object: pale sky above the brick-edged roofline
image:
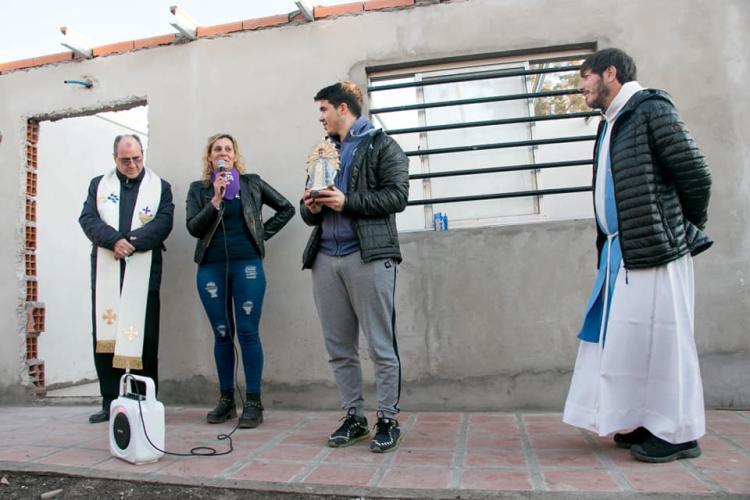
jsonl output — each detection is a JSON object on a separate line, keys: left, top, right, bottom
{"left": 0, "top": 0, "right": 352, "bottom": 62}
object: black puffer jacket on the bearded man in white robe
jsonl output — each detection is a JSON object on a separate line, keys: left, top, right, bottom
{"left": 594, "top": 89, "right": 713, "bottom": 269}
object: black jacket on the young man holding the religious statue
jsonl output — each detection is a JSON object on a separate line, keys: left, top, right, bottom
{"left": 300, "top": 130, "right": 409, "bottom": 269}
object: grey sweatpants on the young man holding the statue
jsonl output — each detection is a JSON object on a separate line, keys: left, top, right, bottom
{"left": 312, "top": 252, "right": 401, "bottom": 418}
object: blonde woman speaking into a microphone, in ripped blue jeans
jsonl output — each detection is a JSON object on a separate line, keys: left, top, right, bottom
{"left": 187, "top": 134, "right": 294, "bottom": 428}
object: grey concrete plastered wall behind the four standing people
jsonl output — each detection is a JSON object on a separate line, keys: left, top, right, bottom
{"left": 0, "top": 0, "right": 750, "bottom": 410}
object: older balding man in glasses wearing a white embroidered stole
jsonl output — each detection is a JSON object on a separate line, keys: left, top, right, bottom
{"left": 78, "top": 135, "right": 174, "bottom": 423}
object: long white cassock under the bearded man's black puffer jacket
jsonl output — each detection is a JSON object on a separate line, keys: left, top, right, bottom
{"left": 563, "top": 82, "right": 705, "bottom": 444}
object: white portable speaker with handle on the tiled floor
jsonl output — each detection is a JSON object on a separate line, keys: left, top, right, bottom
{"left": 109, "top": 374, "right": 164, "bottom": 464}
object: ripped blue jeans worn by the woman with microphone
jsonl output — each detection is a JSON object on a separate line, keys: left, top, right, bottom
{"left": 197, "top": 259, "right": 266, "bottom": 394}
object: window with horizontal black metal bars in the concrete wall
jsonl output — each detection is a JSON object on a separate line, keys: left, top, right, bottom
{"left": 368, "top": 50, "right": 599, "bottom": 231}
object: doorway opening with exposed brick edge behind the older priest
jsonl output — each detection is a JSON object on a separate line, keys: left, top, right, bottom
{"left": 25, "top": 102, "right": 148, "bottom": 399}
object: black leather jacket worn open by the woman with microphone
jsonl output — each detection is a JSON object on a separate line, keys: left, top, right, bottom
{"left": 186, "top": 174, "right": 294, "bottom": 264}
